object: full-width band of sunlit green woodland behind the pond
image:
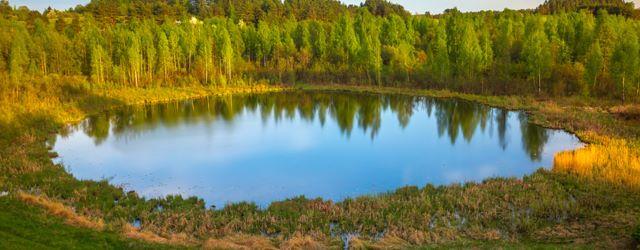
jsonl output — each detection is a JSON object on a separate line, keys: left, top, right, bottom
{"left": 0, "top": 0, "right": 640, "bottom": 101}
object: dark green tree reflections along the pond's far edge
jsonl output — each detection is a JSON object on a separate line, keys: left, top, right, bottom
{"left": 70, "top": 91, "right": 549, "bottom": 161}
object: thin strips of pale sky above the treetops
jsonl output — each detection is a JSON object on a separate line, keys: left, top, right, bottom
{"left": 9, "top": 0, "right": 640, "bottom": 14}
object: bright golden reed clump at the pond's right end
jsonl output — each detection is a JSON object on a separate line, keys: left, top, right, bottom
{"left": 553, "top": 139, "right": 640, "bottom": 188}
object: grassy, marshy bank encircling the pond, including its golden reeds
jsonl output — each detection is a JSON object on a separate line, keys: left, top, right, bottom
{"left": 0, "top": 79, "right": 640, "bottom": 248}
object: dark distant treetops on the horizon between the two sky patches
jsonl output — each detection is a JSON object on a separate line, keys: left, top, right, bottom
{"left": 74, "top": 0, "right": 409, "bottom": 23}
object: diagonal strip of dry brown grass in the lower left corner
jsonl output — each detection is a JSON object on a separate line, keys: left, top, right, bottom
{"left": 18, "top": 192, "right": 104, "bottom": 230}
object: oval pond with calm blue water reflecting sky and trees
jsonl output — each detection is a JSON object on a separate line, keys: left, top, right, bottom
{"left": 54, "top": 91, "right": 582, "bottom": 208}
